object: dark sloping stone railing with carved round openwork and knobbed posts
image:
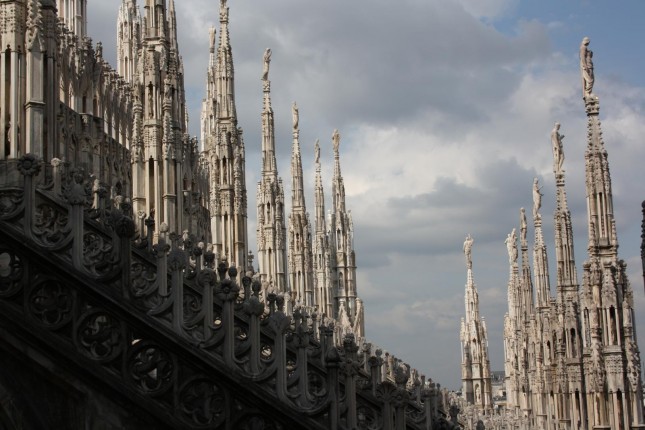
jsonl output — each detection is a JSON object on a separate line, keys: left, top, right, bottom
{"left": 0, "top": 155, "right": 457, "bottom": 430}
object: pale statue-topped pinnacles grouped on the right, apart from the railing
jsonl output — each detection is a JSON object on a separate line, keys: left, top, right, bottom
{"left": 461, "top": 37, "right": 645, "bottom": 430}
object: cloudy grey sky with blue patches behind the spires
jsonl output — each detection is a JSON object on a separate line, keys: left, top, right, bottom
{"left": 88, "top": 0, "right": 645, "bottom": 388}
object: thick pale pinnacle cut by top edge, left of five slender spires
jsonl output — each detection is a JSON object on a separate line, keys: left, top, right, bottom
{"left": 117, "top": 0, "right": 196, "bottom": 239}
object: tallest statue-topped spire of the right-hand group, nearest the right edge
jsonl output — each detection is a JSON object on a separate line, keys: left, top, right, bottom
{"left": 580, "top": 37, "right": 645, "bottom": 428}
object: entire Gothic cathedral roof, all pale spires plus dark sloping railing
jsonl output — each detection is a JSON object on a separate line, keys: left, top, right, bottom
{"left": 0, "top": 0, "right": 645, "bottom": 430}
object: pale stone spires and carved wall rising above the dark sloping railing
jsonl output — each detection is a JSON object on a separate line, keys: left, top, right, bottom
{"left": 0, "top": 0, "right": 363, "bottom": 341}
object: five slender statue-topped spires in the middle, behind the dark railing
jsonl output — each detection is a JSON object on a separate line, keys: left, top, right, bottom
{"left": 186, "top": 0, "right": 364, "bottom": 339}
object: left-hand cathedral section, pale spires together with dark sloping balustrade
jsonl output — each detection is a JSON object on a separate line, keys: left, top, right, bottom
{"left": 0, "top": 0, "right": 456, "bottom": 429}
